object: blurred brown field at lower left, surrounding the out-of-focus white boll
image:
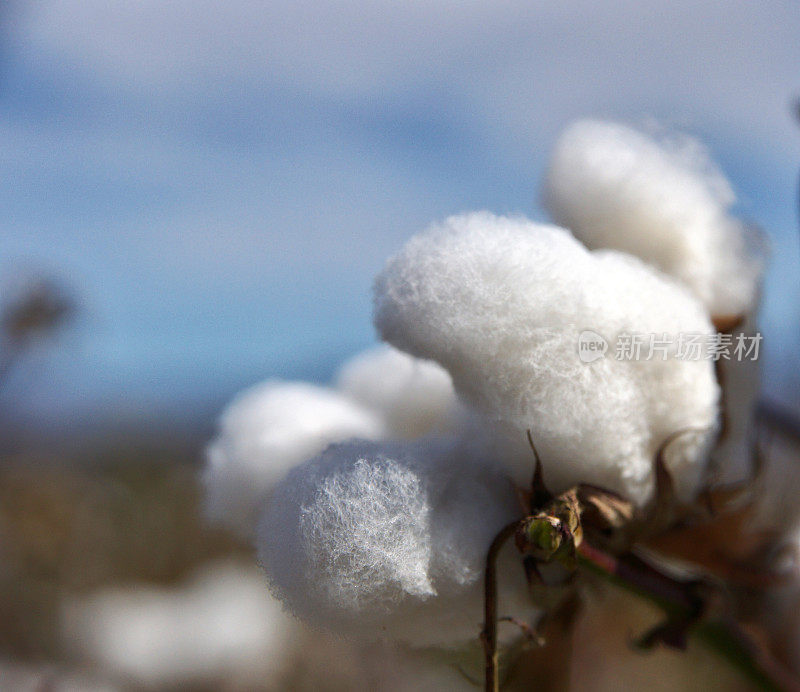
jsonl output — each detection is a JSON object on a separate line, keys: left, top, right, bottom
{"left": 0, "top": 431, "right": 450, "bottom": 692}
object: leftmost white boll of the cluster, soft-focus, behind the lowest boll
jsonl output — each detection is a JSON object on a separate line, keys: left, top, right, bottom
{"left": 203, "top": 381, "right": 385, "bottom": 538}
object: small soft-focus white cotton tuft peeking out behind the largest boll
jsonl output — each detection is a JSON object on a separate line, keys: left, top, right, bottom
{"left": 337, "top": 345, "right": 464, "bottom": 439}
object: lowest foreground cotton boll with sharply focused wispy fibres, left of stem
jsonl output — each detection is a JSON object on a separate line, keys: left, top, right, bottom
{"left": 257, "top": 440, "right": 530, "bottom": 646}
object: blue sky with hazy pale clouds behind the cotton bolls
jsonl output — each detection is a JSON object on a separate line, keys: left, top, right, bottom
{"left": 0, "top": 0, "right": 800, "bottom": 428}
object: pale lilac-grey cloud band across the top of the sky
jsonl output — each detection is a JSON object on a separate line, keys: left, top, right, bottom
{"left": 17, "top": 0, "right": 800, "bottom": 162}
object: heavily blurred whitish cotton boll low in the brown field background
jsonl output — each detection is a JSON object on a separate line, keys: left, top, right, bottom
{"left": 62, "top": 564, "right": 296, "bottom": 689}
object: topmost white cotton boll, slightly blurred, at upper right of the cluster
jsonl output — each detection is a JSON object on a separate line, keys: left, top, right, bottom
{"left": 543, "top": 120, "right": 763, "bottom": 316}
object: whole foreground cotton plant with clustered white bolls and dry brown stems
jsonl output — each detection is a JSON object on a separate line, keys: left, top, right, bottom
{"left": 200, "top": 122, "right": 792, "bottom": 690}
